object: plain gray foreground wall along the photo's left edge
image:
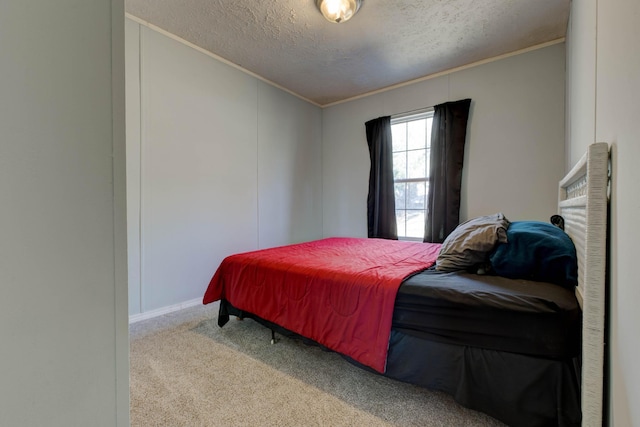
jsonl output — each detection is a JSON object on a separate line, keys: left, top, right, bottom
{"left": 0, "top": 0, "right": 129, "bottom": 427}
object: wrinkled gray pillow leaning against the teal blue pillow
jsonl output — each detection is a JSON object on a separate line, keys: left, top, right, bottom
{"left": 436, "top": 213, "right": 509, "bottom": 271}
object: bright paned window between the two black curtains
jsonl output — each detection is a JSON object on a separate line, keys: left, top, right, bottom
{"left": 391, "top": 111, "right": 433, "bottom": 241}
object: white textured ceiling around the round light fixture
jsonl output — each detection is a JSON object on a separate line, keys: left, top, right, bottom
{"left": 125, "top": 0, "right": 570, "bottom": 106}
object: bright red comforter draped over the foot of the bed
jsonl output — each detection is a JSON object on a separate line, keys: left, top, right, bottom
{"left": 203, "top": 238, "right": 440, "bottom": 372}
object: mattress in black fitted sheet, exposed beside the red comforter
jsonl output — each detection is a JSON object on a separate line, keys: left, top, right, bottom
{"left": 392, "top": 269, "right": 581, "bottom": 359}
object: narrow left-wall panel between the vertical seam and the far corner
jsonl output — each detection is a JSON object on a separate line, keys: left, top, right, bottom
{"left": 258, "top": 82, "right": 322, "bottom": 248}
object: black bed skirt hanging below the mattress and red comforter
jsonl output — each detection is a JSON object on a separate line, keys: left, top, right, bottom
{"left": 218, "top": 300, "right": 582, "bottom": 427}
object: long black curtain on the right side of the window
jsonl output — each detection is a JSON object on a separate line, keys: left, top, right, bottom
{"left": 424, "top": 99, "right": 471, "bottom": 243}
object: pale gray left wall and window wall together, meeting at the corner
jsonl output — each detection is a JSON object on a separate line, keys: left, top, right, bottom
{"left": 126, "top": 25, "right": 565, "bottom": 315}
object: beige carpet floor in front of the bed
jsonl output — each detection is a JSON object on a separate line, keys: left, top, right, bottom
{"left": 130, "top": 304, "right": 503, "bottom": 427}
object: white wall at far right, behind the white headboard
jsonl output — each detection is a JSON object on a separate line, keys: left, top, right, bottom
{"left": 567, "top": 0, "right": 640, "bottom": 427}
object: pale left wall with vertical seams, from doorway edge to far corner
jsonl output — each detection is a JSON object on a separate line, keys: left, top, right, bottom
{"left": 127, "top": 20, "right": 322, "bottom": 314}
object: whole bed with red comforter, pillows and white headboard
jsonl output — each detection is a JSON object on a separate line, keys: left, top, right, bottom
{"left": 203, "top": 143, "right": 608, "bottom": 427}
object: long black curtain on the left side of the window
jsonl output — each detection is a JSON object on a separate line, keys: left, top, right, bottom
{"left": 365, "top": 116, "right": 398, "bottom": 240}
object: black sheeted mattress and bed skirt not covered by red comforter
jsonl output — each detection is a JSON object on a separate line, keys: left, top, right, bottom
{"left": 385, "top": 270, "right": 582, "bottom": 427}
